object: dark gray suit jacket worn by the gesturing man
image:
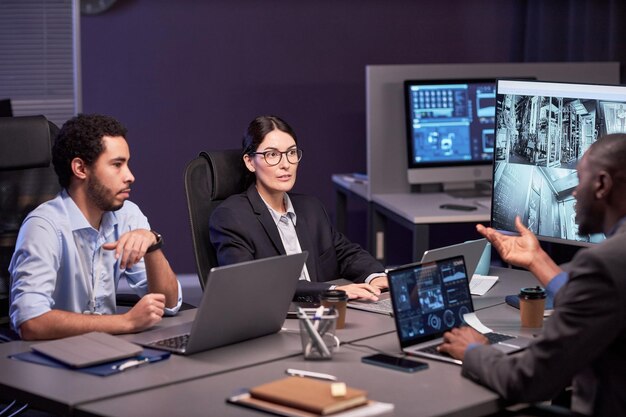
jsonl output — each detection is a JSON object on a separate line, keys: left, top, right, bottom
{"left": 462, "top": 219, "right": 626, "bottom": 416}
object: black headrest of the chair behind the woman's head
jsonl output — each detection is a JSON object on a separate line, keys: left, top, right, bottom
{"left": 200, "top": 149, "right": 250, "bottom": 200}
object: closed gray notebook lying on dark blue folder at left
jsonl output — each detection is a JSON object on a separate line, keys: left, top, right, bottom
{"left": 31, "top": 332, "right": 143, "bottom": 368}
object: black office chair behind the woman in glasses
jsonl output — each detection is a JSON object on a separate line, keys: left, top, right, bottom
{"left": 185, "top": 150, "right": 254, "bottom": 290}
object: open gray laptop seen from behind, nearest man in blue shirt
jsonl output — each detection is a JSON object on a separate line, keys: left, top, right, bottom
{"left": 133, "top": 251, "right": 308, "bottom": 355}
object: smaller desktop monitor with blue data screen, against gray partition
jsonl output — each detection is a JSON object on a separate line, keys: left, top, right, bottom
{"left": 404, "top": 79, "right": 496, "bottom": 190}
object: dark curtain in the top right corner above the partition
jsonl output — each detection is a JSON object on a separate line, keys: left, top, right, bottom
{"left": 523, "top": 0, "right": 626, "bottom": 82}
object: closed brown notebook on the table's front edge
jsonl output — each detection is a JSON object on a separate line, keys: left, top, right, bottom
{"left": 250, "top": 376, "right": 367, "bottom": 415}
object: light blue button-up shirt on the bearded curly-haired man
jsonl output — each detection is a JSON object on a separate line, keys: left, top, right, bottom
{"left": 9, "top": 190, "right": 182, "bottom": 331}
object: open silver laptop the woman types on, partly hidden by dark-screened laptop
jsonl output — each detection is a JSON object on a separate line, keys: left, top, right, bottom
{"left": 348, "top": 239, "right": 487, "bottom": 316}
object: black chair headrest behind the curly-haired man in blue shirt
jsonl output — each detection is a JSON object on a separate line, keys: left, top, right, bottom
{"left": 0, "top": 116, "right": 54, "bottom": 170}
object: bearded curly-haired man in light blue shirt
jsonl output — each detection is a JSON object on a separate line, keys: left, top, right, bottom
{"left": 9, "top": 115, "right": 182, "bottom": 339}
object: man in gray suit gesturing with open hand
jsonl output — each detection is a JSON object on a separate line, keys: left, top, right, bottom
{"left": 439, "top": 134, "right": 626, "bottom": 416}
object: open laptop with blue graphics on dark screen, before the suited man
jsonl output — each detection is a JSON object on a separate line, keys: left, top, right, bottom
{"left": 388, "top": 256, "right": 531, "bottom": 364}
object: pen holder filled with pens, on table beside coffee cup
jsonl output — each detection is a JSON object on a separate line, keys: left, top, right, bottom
{"left": 298, "top": 308, "right": 339, "bottom": 360}
